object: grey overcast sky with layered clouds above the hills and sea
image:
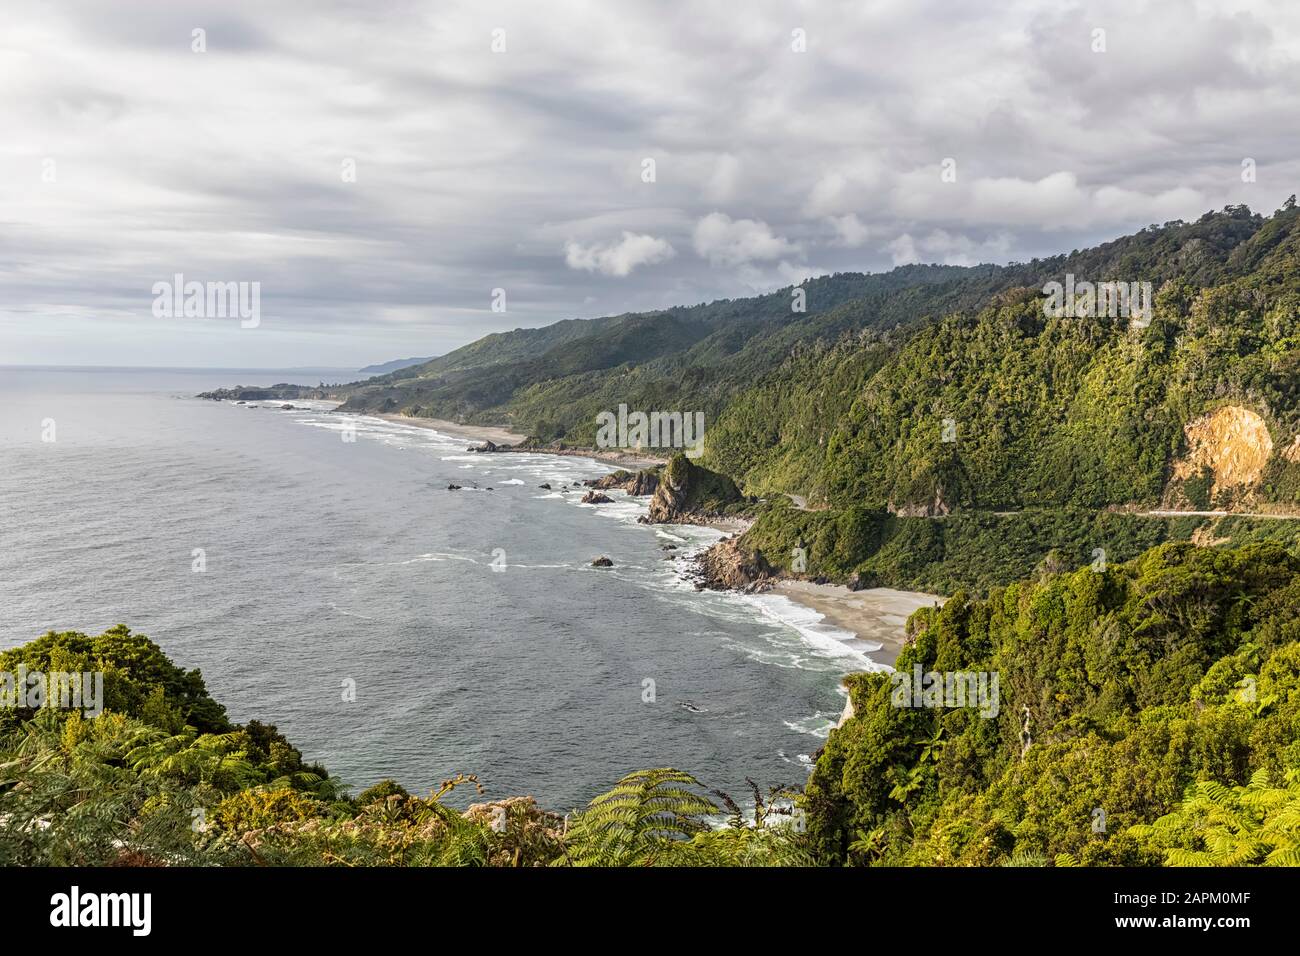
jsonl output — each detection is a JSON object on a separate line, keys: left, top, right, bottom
{"left": 0, "top": 0, "right": 1300, "bottom": 368}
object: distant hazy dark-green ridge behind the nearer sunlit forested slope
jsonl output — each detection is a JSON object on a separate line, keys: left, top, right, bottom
{"left": 335, "top": 267, "right": 971, "bottom": 429}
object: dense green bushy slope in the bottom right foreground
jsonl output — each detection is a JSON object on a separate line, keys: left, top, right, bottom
{"left": 806, "top": 545, "right": 1300, "bottom": 866}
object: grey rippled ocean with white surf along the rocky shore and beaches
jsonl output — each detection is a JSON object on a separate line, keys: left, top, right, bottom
{"left": 0, "top": 367, "right": 876, "bottom": 810}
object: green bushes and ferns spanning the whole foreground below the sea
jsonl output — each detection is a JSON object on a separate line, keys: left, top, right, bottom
{"left": 0, "top": 542, "right": 1300, "bottom": 866}
